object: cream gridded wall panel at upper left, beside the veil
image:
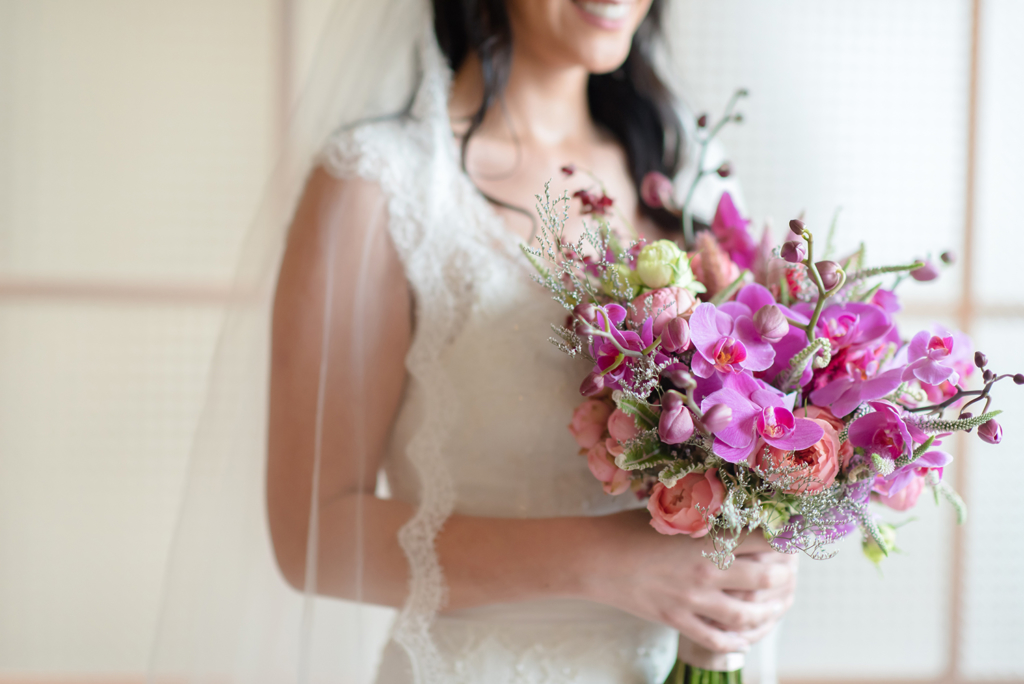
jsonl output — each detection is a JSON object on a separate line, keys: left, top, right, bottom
{"left": 0, "top": 0, "right": 276, "bottom": 281}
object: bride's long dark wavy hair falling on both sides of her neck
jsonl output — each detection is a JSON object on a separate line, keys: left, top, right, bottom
{"left": 433, "top": 0, "right": 684, "bottom": 229}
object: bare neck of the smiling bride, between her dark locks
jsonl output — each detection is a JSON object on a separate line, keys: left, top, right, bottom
{"left": 449, "top": 53, "right": 598, "bottom": 146}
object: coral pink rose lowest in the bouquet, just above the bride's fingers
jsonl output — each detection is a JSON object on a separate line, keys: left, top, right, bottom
{"left": 647, "top": 468, "right": 725, "bottom": 539}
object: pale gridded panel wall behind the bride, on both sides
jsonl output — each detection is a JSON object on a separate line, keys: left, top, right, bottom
{"left": 0, "top": 0, "right": 1024, "bottom": 680}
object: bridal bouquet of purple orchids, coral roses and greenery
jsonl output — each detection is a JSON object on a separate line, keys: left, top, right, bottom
{"left": 524, "top": 93, "right": 1024, "bottom": 681}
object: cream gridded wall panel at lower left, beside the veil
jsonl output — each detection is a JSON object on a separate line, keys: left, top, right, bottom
{"left": 0, "top": 301, "right": 220, "bottom": 674}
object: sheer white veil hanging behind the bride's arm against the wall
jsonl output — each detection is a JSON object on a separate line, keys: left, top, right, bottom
{"left": 148, "top": 0, "right": 431, "bottom": 683}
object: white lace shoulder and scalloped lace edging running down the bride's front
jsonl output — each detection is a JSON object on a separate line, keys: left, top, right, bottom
{"left": 321, "top": 28, "right": 464, "bottom": 684}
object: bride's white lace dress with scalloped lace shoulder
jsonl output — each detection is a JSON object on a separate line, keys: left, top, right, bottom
{"left": 324, "top": 40, "right": 749, "bottom": 684}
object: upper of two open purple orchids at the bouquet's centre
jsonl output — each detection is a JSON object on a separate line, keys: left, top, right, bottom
{"left": 690, "top": 294, "right": 775, "bottom": 378}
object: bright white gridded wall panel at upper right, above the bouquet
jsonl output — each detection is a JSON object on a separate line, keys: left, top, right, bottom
{"left": 672, "top": 0, "right": 971, "bottom": 309}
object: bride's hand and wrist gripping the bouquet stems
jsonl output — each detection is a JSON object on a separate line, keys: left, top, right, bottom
{"left": 586, "top": 511, "right": 797, "bottom": 653}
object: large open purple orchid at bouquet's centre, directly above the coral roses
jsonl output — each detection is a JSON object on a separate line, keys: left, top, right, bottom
{"left": 700, "top": 373, "right": 824, "bottom": 463}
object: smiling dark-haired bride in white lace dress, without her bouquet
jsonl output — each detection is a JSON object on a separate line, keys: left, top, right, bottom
{"left": 155, "top": 0, "right": 796, "bottom": 684}
